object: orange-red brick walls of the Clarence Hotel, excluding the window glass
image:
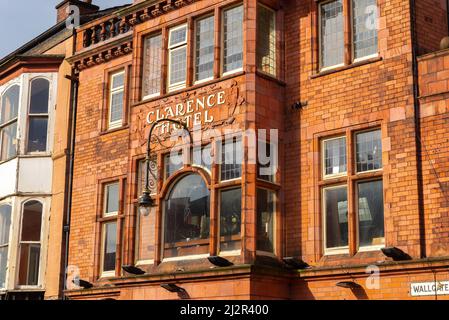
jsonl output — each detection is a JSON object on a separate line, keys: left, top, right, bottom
{"left": 66, "top": 0, "right": 449, "bottom": 299}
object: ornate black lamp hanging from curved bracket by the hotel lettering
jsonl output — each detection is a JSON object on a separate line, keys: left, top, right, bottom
{"left": 138, "top": 119, "right": 192, "bottom": 216}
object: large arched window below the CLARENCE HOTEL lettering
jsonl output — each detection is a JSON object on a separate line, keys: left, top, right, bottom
{"left": 164, "top": 174, "right": 210, "bottom": 258}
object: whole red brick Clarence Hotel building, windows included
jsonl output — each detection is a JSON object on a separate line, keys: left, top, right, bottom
{"left": 65, "top": 0, "right": 449, "bottom": 299}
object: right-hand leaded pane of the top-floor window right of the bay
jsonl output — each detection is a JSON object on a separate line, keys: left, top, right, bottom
{"left": 352, "top": 0, "right": 377, "bottom": 59}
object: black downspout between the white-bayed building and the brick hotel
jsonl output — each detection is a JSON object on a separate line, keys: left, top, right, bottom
{"left": 61, "top": 29, "right": 79, "bottom": 300}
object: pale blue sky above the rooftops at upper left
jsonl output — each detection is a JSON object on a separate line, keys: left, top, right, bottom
{"left": 0, "top": 0, "right": 132, "bottom": 58}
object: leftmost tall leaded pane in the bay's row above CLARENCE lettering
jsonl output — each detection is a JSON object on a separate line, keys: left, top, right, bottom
{"left": 142, "top": 34, "right": 162, "bottom": 97}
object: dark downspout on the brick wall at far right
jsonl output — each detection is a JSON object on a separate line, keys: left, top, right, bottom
{"left": 410, "top": 0, "right": 426, "bottom": 258}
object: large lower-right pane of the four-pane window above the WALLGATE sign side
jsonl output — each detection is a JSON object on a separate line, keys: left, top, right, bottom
{"left": 358, "top": 180, "right": 385, "bottom": 247}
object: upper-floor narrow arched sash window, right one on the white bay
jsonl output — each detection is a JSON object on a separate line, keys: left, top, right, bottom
{"left": 27, "top": 78, "right": 50, "bottom": 153}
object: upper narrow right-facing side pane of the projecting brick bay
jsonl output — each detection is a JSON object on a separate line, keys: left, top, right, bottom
{"left": 257, "top": 5, "right": 276, "bottom": 76}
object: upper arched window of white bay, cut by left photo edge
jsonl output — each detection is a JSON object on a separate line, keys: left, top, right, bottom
{"left": 0, "top": 85, "right": 20, "bottom": 161}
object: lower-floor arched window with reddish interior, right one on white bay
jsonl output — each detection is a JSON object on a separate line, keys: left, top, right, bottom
{"left": 18, "top": 200, "right": 43, "bottom": 286}
